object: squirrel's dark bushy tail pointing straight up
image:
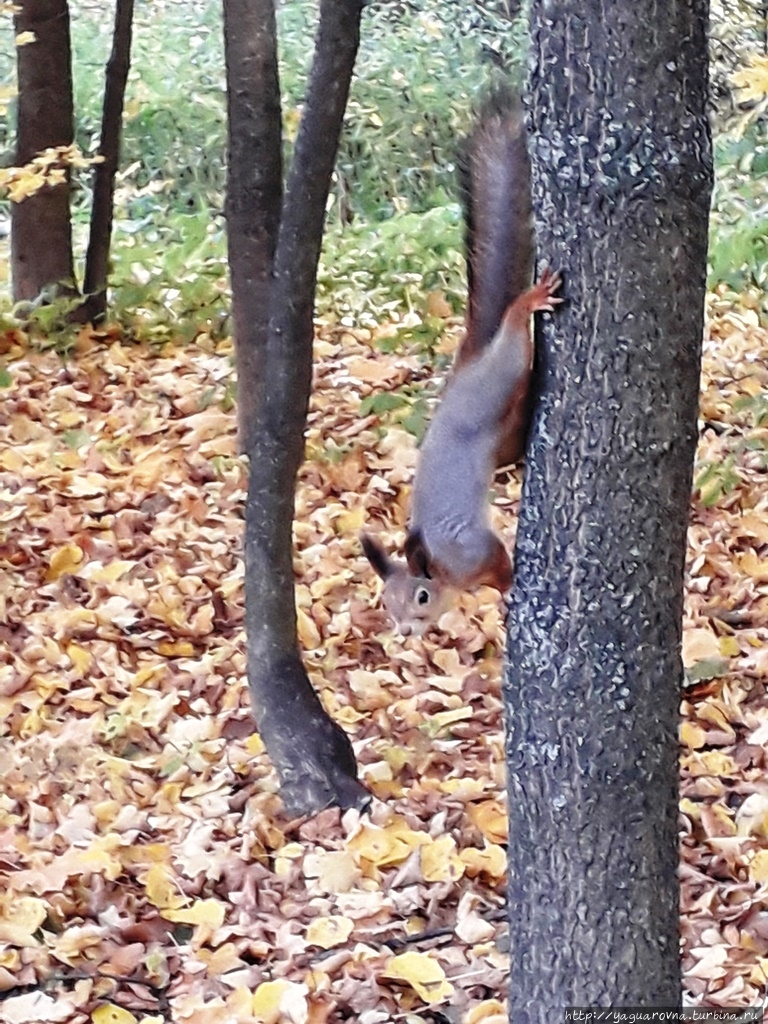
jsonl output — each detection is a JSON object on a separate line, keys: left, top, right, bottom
{"left": 458, "top": 88, "right": 534, "bottom": 365}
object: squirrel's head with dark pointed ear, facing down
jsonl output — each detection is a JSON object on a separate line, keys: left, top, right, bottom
{"left": 360, "top": 534, "right": 447, "bottom": 636}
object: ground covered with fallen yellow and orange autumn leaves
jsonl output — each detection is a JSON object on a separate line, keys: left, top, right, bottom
{"left": 0, "top": 299, "right": 768, "bottom": 1024}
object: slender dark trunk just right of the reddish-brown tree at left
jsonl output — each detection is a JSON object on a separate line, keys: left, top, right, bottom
{"left": 79, "top": 0, "right": 133, "bottom": 323}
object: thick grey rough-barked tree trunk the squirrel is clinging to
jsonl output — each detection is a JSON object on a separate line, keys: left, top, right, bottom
{"left": 505, "top": 0, "right": 712, "bottom": 1011}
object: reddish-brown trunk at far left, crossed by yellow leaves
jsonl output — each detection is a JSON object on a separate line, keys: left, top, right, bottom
{"left": 10, "top": 0, "right": 75, "bottom": 302}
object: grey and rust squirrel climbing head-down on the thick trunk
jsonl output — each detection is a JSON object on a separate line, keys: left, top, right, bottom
{"left": 360, "top": 97, "right": 562, "bottom": 636}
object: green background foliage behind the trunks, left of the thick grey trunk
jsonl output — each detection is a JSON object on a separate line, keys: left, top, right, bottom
{"left": 0, "top": 0, "right": 523, "bottom": 327}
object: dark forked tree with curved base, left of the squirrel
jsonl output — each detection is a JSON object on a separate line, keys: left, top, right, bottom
{"left": 224, "top": 0, "right": 367, "bottom": 813}
